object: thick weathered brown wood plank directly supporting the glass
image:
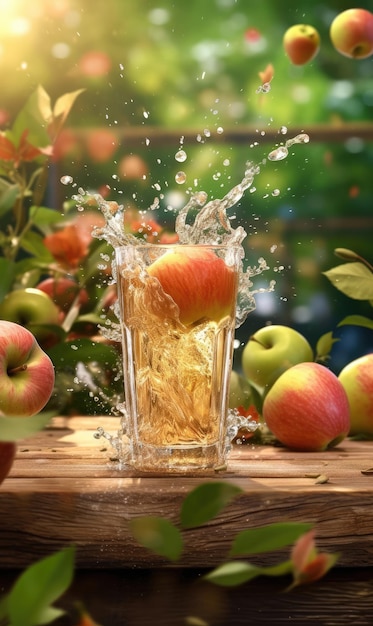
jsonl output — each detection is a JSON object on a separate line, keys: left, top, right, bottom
{"left": 0, "top": 418, "right": 373, "bottom": 568}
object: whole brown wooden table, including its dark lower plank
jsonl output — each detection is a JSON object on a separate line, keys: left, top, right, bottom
{"left": 0, "top": 416, "right": 373, "bottom": 626}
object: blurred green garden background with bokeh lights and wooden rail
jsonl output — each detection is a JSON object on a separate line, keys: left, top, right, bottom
{"left": 0, "top": 0, "right": 373, "bottom": 371}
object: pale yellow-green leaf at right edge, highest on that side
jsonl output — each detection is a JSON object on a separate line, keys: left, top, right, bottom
{"left": 323, "top": 263, "right": 373, "bottom": 300}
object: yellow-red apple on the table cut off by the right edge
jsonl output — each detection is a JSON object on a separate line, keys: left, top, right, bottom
{"left": 338, "top": 353, "right": 373, "bottom": 435}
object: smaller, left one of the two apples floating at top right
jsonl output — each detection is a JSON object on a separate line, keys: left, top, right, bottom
{"left": 283, "top": 24, "right": 320, "bottom": 65}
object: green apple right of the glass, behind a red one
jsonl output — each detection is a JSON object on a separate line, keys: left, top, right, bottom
{"left": 242, "top": 324, "right": 314, "bottom": 391}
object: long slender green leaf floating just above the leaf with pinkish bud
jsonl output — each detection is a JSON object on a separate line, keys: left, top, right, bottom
{"left": 230, "top": 522, "right": 312, "bottom": 556}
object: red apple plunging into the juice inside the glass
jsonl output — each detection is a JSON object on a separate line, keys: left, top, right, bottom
{"left": 147, "top": 246, "right": 238, "bottom": 325}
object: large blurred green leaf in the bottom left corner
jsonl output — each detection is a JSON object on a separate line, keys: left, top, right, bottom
{"left": 7, "top": 547, "right": 75, "bottom": 626}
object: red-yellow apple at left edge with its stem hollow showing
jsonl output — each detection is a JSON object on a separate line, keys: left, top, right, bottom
{"left": 0, "top": 320, "right": 54, "bottom": 417}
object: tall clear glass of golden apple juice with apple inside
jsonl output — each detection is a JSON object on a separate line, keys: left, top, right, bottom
{"left": 116, "top": 244, "right": 241, "bottom": 470}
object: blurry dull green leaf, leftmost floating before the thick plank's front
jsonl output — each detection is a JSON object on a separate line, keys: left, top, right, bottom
{"left": 130, "top": 516, "right": 183, "bottom": 561}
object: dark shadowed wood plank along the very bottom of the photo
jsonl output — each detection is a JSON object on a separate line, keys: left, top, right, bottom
{"left": 0, "top": 568, "right": 373, "bottom": 626}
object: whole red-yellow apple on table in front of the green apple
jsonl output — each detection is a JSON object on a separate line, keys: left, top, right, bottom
{"left": 263, "top": 363, "right": 350, "bottom": 451}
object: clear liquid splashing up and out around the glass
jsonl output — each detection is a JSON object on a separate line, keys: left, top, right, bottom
{"left": 73, "top": 133, "right": 309, "bottom": 464}
